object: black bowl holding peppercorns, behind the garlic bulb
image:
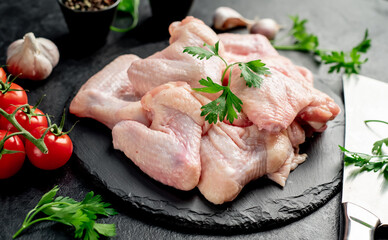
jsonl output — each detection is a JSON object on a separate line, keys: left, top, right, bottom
{"left": 57, "top": 0, "right": 120, "bottom": 48}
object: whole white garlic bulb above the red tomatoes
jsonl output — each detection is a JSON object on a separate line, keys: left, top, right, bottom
{"left": 7, "top": 32, "right": 59, "bottom": 80}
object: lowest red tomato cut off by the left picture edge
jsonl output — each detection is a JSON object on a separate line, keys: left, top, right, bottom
{"left": 0, "top": 130, "right": 26, "bottom": 179}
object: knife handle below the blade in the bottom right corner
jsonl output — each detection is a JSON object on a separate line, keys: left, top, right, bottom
{"left": 342, "top": 202, "right": 380, "bottom": 240}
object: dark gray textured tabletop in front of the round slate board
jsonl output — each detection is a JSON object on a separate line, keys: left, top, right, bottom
{"left": 0, "top": 162, "right": 340, "bottom": 240}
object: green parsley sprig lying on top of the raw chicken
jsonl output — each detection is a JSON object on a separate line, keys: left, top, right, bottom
{"left": 183, "top": 41, "right": 271, "bottom": 124}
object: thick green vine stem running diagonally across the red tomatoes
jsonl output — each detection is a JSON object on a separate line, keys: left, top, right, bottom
{"left": 0, "top": 104, "right": 48, "bottom": 154}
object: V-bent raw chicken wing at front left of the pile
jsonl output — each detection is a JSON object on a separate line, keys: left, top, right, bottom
{"left": 112, "top": 82, "right": 204, "bottom": 190}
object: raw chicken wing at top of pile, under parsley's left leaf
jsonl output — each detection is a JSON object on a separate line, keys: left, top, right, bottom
{"left": 128, "top": 17, "right": 225, "bottom": 98}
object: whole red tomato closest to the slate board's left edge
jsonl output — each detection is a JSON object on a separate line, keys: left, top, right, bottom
{"left": 26, "top": 127, "right": 73, "bottom": 170}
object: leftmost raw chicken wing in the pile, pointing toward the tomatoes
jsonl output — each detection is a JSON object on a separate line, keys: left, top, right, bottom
{"left": 70, "top": 54, "right": 149, "bottom": 128}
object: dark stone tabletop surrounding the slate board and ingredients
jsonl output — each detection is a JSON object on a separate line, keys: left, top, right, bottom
{"left": 0, "top": 0, "right": 388, "bottom": 239}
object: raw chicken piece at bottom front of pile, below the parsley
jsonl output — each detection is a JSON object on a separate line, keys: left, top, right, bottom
{"left": 198, "top": 123, "right": 306, "bottom": 204}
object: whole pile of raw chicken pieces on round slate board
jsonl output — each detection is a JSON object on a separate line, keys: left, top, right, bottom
{"left": 70, "top": 17, "right": 340, "bottom": 204}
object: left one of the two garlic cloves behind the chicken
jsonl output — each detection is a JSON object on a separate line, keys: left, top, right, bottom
{"left": 213, "top": 7, "right": 252, "bottom": 31}
